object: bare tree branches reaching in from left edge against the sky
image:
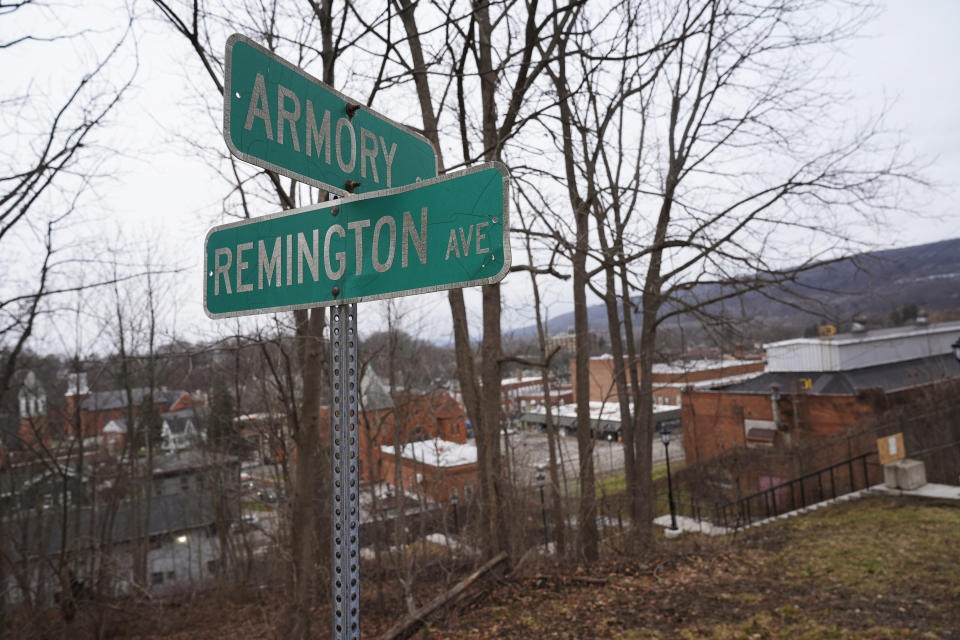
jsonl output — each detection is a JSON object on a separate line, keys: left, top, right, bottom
{"left": 0, "top": 3, "right": 132, "bottom": 424}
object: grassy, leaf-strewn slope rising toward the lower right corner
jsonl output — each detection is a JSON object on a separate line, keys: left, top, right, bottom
{"left": 420, "top": 498, "right": 960, "bottom": 640}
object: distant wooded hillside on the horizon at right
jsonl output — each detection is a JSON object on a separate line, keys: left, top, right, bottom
{"left": 513, "top": 238, "right": 960, "bottom": 338}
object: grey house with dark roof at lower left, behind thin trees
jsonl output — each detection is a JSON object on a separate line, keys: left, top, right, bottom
{"left": 0, "top": 451, "right": 240, "bottom": 606}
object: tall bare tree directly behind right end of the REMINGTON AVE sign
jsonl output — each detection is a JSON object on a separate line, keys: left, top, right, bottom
{"left": 397, "top": 0, "right": 579, "bottom": 558}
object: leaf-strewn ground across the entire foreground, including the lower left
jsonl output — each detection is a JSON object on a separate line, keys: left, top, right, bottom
{"left": 9, "top": 497, "right": 960, "bottom": 640}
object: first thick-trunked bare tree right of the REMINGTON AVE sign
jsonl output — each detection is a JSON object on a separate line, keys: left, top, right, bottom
{"left": 549, "top": 3, "right": 660, "bottom": 562}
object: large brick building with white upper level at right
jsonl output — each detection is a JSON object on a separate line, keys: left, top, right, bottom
{"left": 681, "top": 323, "right": 960, "bottom": 491}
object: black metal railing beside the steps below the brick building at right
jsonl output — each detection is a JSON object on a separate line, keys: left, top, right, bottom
{"left": 658, "top": 451, "right": 877, "bottom": 529}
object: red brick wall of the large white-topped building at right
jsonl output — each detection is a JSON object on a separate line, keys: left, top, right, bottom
{"left": 681, "top": 380, "right": 960, "bottom": 495}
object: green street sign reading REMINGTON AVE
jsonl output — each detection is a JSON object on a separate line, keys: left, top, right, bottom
{"left": 203, "top": 162, "right": 510, "bottom": 318}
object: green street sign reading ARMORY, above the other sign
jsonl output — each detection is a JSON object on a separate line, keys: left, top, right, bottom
{"left": 223, "top": 34, "right": 437, "bottom": 195}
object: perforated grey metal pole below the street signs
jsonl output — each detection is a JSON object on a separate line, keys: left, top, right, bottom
{"left": 330, "top": 304, "right": 360, "bottom": 640}
